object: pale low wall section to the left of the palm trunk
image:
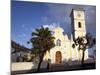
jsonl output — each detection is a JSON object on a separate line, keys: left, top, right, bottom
{"left": 11, "top": 62, "right": 37, "bottom": 71}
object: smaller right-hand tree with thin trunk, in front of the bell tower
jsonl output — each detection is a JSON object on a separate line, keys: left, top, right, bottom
{"left": 72, "top": 33, "right": 96, "bottom": 67}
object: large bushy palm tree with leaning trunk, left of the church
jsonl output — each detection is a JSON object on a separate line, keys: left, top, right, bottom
{"left": 27, "top": 27, "right": 54, "bottom": 72}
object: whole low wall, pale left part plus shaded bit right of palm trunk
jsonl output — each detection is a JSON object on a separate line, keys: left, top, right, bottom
{"left": 11, "top": 62, "right": 47, "bottom": 71}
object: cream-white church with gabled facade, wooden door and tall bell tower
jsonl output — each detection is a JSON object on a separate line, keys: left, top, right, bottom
{"left": 44, "top": 9, "right": 88, "bottom": 64}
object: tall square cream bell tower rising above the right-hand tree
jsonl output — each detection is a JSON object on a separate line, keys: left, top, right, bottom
{"left": 70, "top": 9, "right": 86, "bottom": 40}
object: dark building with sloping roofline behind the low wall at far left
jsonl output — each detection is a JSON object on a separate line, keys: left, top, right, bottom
{"left": 11, "top": 41, "right": 31, "bottom": 62}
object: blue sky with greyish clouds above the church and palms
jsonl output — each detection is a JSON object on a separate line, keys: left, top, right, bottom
{"left": 11, "top": 1, "right": 96, "bottom": 48}
